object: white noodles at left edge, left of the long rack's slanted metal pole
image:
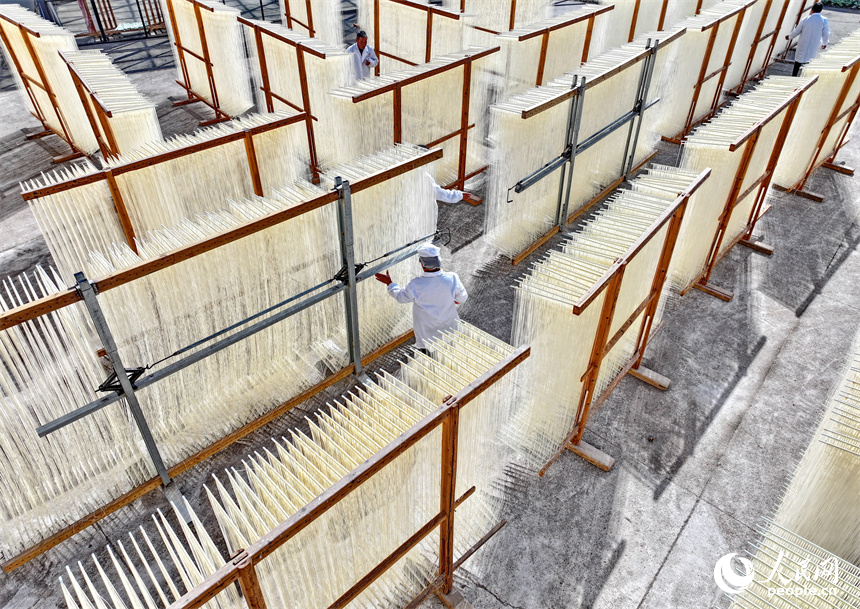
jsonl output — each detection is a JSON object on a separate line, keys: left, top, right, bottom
{"left": 0, "top": 268, "right": 153, "bottom": 556}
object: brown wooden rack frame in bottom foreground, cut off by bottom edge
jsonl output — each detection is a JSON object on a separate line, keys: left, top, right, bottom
{"left": 164, "top": 347, "right": 530, "bottom": 609}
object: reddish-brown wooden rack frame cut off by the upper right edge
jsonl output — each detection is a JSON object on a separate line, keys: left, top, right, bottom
{"left": 774, "top": 56, "right": 860, "bottom": 203}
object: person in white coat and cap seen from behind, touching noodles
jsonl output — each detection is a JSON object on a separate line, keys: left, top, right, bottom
{"left": 376, "top": 244, "right": 469, "bottom": 353}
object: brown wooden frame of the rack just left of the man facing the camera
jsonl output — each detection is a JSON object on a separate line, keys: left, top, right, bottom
{"left": 239, "top": 17, "right": 326, "bottom": 184}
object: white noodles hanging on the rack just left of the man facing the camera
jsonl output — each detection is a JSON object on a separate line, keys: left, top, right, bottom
{"left": 240, "top": 21, "right": 352, "bottom": 167}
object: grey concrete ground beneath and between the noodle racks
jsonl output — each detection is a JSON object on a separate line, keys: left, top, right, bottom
{"left": 0, "top": 4, "right": 860, "bottom": 609}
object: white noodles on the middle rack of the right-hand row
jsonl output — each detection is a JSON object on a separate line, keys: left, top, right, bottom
{"left": 671, "top": 76, "right": 815, "bottom": 290}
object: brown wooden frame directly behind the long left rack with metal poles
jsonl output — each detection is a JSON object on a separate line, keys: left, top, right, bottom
{"left": 21, "top": 114, "right": 305, "bottom": 254}
